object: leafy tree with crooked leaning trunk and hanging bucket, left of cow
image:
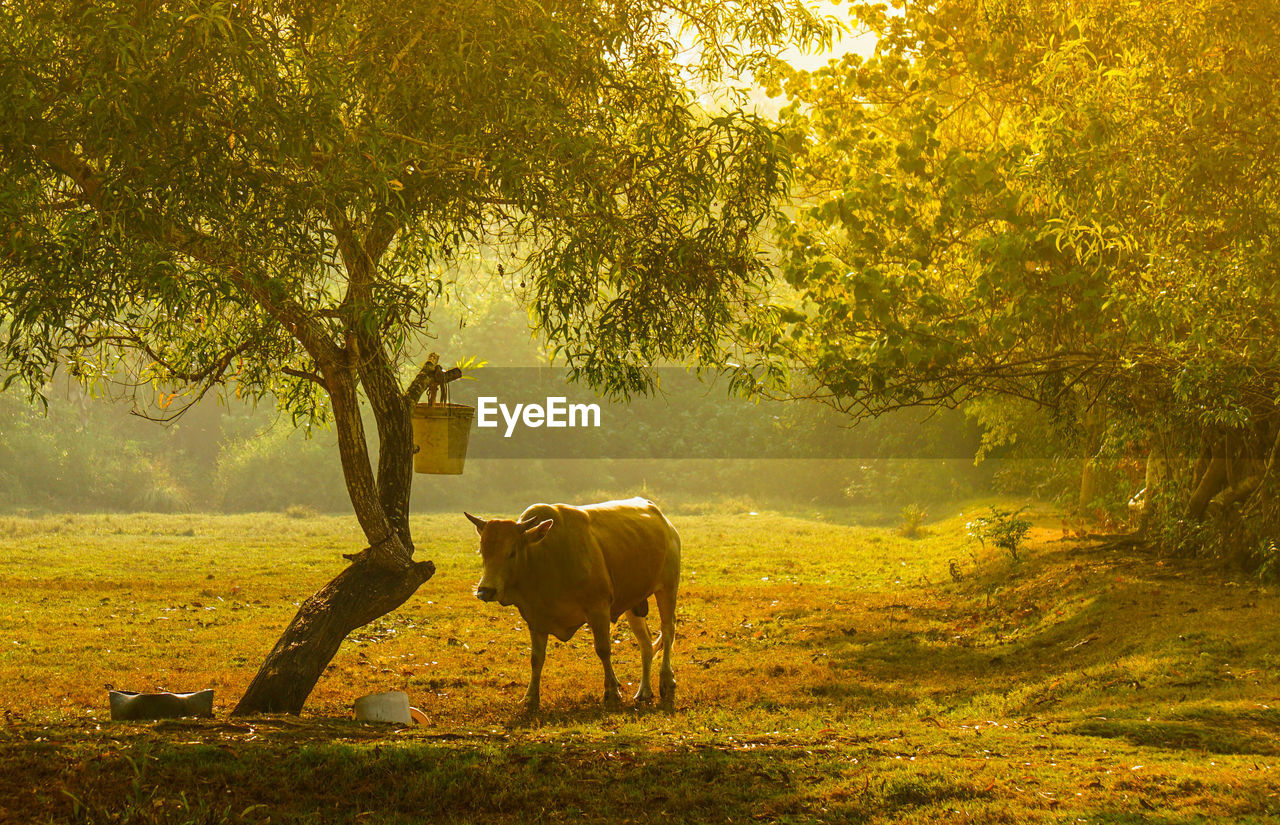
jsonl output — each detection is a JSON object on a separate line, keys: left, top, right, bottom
{"left": 0, "top": 0, "right": 824, "bottom": 712}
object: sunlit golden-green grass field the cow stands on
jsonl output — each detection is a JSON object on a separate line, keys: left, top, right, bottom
{"left": 0, "top": 501, "right": 1280, "bottom": 824}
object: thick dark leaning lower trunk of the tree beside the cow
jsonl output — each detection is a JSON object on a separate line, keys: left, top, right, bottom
{"left": 232, "top": 559, "right": 435, "bottom": 716}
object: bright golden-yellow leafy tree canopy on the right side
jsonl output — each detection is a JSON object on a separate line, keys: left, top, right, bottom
{"left": 762, "top": 0, "right": 1280, "bottom": 565}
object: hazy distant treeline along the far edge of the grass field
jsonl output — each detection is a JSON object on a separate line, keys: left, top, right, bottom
{"left": 0, "top": 295, "right": 1029, "bottom": 514}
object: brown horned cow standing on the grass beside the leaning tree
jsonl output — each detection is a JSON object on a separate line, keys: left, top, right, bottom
{"left": 465, "top": 499, "right": 680, "bottom": 710}
